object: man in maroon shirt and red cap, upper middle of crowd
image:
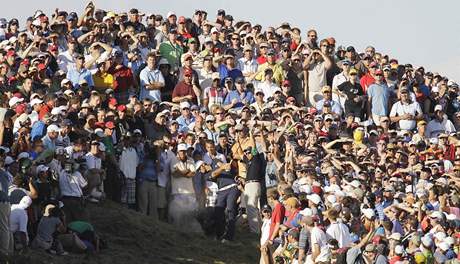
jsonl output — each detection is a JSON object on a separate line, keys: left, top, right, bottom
{"left": 172, "top": 69, "right": 201, "bottom": 104}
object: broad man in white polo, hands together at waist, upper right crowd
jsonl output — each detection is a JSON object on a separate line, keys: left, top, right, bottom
{"left": 390, "top": 87, "right": 423, "bottom": 131}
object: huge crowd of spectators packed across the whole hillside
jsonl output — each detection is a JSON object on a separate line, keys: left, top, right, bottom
{"left": 0, "top": 2, "right": 460, "bottom": 264}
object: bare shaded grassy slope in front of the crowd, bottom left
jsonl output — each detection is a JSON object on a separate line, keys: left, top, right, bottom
{"left": 9, "top": 201, "right": 258, "bottom": 264}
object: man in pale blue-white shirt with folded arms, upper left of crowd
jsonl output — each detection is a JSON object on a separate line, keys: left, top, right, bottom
{"left": 139, "top": 53, "right": 165, "bottom": 102}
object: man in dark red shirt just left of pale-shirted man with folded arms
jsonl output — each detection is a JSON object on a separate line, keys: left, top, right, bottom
{"left": 109, "top": 51, "right": 137, "bottom": 104}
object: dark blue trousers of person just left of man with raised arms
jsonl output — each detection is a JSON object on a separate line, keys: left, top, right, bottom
{"left": 215, "top": 186, "right": 240, "bottom": 240}
